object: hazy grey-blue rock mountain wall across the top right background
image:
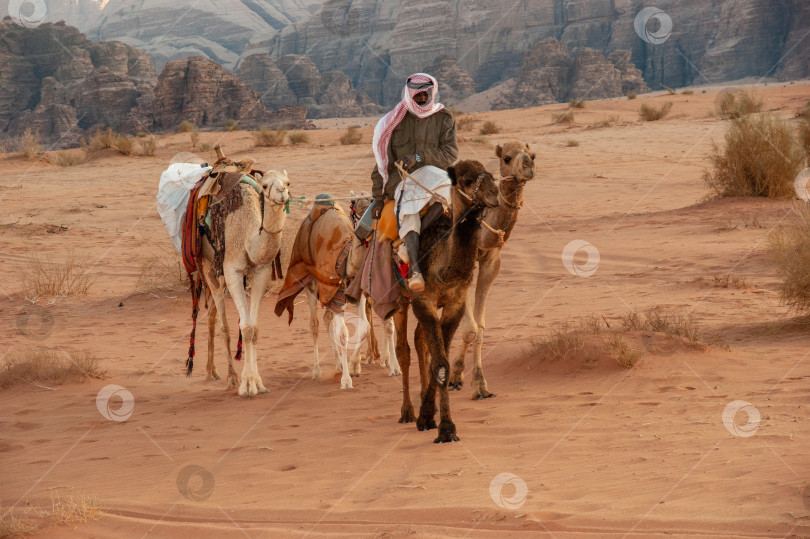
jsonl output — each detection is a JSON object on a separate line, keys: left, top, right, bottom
{"left": 244, "top": 0, "right": 810, "bottom": 105}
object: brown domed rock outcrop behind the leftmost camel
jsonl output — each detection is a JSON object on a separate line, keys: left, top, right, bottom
{"left": 127, "top": 56, "right": 307, "bottom": 131}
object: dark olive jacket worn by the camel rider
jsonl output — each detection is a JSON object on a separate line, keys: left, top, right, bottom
{"left": 371, "top": 109, "right": 458, "bottom": 199}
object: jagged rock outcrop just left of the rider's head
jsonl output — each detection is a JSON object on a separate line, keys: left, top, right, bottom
{"left": 236, "top": 53, "right": 382, "bottom": 118}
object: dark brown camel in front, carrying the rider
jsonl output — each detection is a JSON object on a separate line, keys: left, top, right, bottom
{"left": 394, "top": 161, "right": 498, "bottom": 443}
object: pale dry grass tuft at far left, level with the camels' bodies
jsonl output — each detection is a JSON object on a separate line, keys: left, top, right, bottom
{"left": 23, "top": 251, "right": 93, "bottom": 300}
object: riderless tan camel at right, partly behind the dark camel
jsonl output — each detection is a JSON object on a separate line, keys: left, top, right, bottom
{"left": 450, "top": 140, "right": 535, "bottom": 399}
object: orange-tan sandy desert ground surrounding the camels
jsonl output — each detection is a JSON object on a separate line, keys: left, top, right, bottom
{"left": 0, "top": 83, "right": 810, "bottom": 537}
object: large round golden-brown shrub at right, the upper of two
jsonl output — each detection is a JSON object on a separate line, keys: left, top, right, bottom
{"left": 703, "top": 114, "right": 804, "bottom": 198}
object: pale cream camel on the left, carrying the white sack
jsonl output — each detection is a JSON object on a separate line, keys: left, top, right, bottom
{"left": 201, "top": 170, "right": 290, "bottom": 397}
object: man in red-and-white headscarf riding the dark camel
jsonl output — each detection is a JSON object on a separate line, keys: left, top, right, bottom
{"left": 371, "top": 73, "right": 458, "bottom": 292}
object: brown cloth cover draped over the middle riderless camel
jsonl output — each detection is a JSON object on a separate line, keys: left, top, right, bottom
{"left": 275, "top": 195, "right": 354, "bottom": 322}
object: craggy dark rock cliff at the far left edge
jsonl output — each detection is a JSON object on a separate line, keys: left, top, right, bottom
{"left": 0, "top": 18, "right": 157, "bottom": 143}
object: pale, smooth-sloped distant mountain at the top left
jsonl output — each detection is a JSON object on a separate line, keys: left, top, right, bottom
{"left": 0, "top": 0, "right": 323, "bottom": 71}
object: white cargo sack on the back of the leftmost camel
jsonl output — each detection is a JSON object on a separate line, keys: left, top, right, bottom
{"left": 157, "top": 163, "right": 211, "bottom": 252}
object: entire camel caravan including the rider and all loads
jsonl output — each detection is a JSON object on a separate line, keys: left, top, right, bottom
{"left": 157, "top": 74, "right": 535, "bottom": 443}
